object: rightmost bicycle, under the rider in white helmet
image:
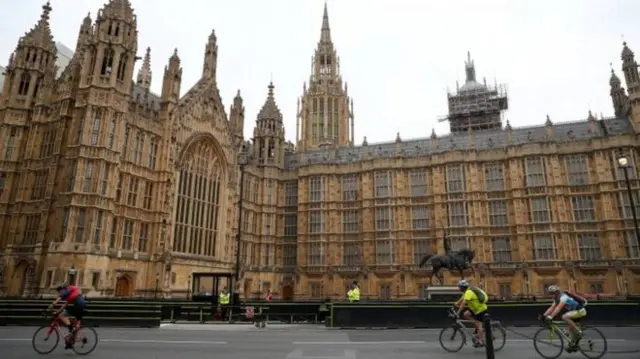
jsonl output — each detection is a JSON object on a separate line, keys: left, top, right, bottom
{"left": 533, "top": 319, "right": 607, "bottom": 359}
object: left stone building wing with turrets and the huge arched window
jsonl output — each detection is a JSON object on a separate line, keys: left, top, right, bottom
{"left": 0, "top": 0, "right": 242, "bottom": 296}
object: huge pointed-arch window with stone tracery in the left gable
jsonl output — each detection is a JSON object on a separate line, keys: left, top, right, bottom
{"left": 173, "top": 140, "right": 226, "bottom": 257}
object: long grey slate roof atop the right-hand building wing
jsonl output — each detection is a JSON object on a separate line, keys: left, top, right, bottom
{"left": 284, "top": 118, "right": 633, "bottom": 169}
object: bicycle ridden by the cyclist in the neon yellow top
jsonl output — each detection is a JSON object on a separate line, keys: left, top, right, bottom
{"left": 438, "top": 308, "right": 507, "bottom": 353}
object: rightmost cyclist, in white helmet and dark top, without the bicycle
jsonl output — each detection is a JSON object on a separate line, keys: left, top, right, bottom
{"left": 543, "top": 285, "right": 587, "bottom": 352}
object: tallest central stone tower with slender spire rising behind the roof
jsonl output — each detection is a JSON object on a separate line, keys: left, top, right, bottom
{"left": 296, "top": 3, "right": 353, "bottom": 151}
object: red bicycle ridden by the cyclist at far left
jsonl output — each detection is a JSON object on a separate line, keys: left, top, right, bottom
{"left": 31, "top": 311, "right": 98, "bottom": 355}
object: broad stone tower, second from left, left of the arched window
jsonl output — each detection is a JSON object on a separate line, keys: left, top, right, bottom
{"left": 61, "top": 0, "right": 139, "bottom": 268}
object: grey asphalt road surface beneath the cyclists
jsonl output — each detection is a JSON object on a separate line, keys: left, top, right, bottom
{"left": 0, "top": 324, "right": 640, "bottom": 359}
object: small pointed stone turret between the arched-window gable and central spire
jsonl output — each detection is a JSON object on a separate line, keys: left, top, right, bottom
{"left": 253, "top": 83, "right": 285, "bottom": 168}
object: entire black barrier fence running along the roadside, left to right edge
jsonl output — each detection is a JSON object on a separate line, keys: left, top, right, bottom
{"left": 0, "top": 299, "right": 640, "bottom": 328}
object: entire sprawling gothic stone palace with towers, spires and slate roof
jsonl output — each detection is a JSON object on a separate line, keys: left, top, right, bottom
{"left": 0, "top": 0, "right": 640, "bottom": 298}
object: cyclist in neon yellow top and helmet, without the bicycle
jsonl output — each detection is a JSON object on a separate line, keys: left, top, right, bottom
{"left": 456, "top": 279, "right": 489, "bottom": 347}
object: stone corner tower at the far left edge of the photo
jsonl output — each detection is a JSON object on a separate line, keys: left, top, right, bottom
{"left": 0, "top": 2, "right": 57, "bottom": 294}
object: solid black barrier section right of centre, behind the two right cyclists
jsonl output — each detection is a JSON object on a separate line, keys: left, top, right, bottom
{"left": 325, "top": 301, "right": 640, "bottom": 329}
